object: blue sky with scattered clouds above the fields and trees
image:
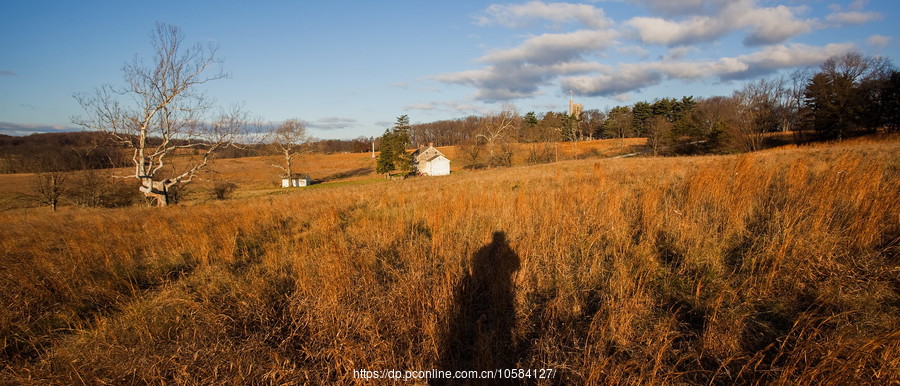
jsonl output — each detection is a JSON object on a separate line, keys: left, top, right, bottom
{"left": 0, "top": 0, "right": 900, "bottom": 138}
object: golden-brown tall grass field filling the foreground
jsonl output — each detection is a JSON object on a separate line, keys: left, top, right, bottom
{"left": 0, "top": 136, "right": 900, "bottom": 384}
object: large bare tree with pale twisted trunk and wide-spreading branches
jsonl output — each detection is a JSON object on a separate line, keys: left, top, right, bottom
{"left": 73, "top": 23, "right": 247, "bottom": 206}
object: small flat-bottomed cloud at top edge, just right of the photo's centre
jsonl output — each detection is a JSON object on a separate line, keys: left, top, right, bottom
{"left": 477, "top": 1, "right": 613, "bottom": 29}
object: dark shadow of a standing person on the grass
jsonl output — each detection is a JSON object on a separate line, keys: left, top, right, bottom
{"left": 431, "top": 232, "right": 520, "bottom": 384}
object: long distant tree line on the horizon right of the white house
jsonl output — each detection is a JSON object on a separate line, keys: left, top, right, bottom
{"left": 400, "top": 52, "right": 900, "bottom": 157}
